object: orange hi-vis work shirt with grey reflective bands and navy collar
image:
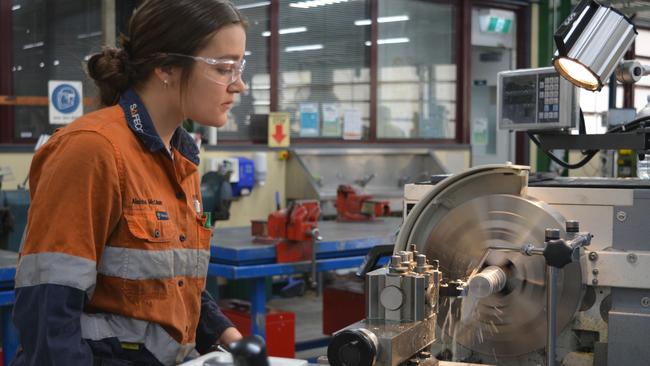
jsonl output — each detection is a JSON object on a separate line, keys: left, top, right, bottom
{"left": 16, "top": 90, "right": 212, "bottom": 365}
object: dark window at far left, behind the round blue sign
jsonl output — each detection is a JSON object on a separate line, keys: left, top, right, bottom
{"left": 9, "top": 0, "right": 102, "bottom": 142}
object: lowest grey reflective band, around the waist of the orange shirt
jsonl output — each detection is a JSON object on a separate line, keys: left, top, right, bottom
{"left": 81, "top": 313, "right": 198, "bottom": 365}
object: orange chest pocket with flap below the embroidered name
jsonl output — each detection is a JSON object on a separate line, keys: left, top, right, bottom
{"left": 124, "top": 208, "right": 176, "bottom": 243}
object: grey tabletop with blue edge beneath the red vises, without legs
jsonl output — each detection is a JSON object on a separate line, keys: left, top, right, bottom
{"left": 210, "top": 217, "right": 402, "bottom": 265}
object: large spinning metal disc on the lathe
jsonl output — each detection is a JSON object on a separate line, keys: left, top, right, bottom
{"left": 409, "top": 194, "right": 582, "bottom": 357}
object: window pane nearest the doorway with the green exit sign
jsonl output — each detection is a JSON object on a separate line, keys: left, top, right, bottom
{"left": 377, "top": 0, "right": 456, "bottom": 139}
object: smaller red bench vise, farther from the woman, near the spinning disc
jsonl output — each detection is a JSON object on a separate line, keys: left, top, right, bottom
{"left": 334, "top": 184, "right": 390, "bottom": 221}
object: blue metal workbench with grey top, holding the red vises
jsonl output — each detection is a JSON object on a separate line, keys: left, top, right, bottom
{"left": 208, "top": 217, "right": 402, "bottom": 337}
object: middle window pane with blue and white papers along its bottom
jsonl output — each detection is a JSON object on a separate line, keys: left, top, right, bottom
{"left": 278, "top": 0, "right": 370, "bottom": 140}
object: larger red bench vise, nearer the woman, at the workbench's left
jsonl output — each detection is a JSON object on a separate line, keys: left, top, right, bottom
{"left": 251, "top": 200, "right": 322, "bottom": 263}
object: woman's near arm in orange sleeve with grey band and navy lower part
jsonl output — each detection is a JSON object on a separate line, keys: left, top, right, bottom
{"left": 13, "top": 131, "right": 121, "bottom": 366}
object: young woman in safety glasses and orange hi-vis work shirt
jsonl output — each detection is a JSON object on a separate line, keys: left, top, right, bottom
{"left": 13, "top": 0, "right": 246, "bottom": 366}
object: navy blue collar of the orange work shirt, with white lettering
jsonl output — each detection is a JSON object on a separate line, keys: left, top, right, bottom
{"left": 119, "top": 89, "right": 199, "bottom": 165}
